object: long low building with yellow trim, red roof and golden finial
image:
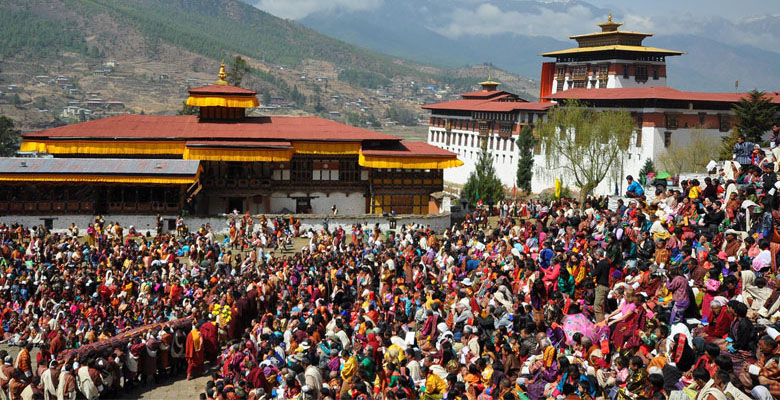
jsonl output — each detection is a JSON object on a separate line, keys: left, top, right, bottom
{"left": 6, "top": 63, "right": 463, "bottom": 216}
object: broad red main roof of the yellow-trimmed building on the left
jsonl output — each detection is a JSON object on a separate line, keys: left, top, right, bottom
{"left": 23, "top": 114, "right": 401, "bottom": 142}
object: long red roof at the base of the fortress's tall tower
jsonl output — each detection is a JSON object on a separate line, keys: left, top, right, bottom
{"left": 547, "top": 86, "right": 780, "bottom": 103}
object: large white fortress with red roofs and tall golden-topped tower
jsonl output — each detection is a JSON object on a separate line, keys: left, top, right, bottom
{"left": 422, "top": 16, "right": 780, "bottom": 194}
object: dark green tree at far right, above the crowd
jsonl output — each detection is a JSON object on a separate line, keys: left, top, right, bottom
{"left": 732, "top": 89, "right": 777, "bottom": 143}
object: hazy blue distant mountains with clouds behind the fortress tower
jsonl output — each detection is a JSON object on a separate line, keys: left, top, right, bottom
{"left": 262, "top": 0, "right": 780, "bottom": 91}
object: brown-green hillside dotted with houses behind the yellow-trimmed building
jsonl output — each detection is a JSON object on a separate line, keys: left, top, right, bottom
{"left": 0, "top": 0, "right": 537, "bottom": 129}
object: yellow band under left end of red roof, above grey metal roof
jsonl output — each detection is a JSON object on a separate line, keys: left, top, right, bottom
{"left": 20, "top": 140, "right": 186, "bottom": 155}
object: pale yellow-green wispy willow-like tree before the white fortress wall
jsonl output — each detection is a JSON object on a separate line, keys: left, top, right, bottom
{"left": 536, "top": 101, "right": 634, "bottom": 200}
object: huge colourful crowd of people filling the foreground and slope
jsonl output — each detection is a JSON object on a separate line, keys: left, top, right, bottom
{"left": 0, "top": 144, "right": 780, "bottom": 400}
